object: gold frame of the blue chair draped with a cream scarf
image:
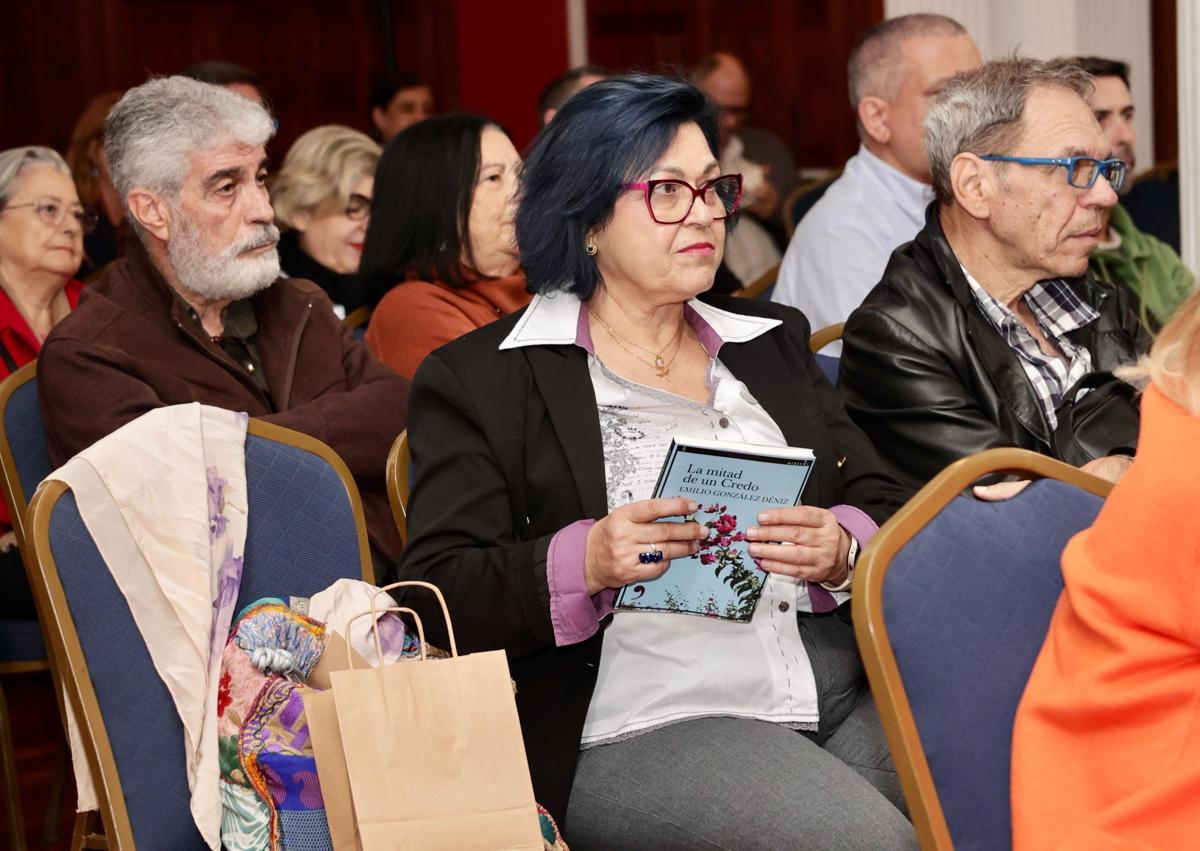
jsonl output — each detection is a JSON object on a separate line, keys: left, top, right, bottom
{"left": 29, "top": 420, "right": 374, "bottom": 851}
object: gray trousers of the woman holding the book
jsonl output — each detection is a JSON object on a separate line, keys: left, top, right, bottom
{"left": 563, "top": 616, "right": 917, "bottom": 851}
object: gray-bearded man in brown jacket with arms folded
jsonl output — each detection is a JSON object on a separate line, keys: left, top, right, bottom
{"left": 37, "top": 77, "right": 408, "bottom": 557}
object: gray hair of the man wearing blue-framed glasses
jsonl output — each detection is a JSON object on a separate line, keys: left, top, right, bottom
{"left": 924, "top": 56, "right": 1093, "bottom": 204}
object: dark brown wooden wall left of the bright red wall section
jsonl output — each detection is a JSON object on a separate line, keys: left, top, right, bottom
{"left": 0, "top": 0, "right": 458, "bottom": 158}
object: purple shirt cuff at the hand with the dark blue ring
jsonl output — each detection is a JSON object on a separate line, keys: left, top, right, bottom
{"left": 546, "top": 520, "right": 617, "bottom": 647}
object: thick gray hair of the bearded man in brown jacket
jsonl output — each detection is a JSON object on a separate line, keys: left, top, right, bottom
{"left": 104, "top": 77, "right": 275, "bottom": 208}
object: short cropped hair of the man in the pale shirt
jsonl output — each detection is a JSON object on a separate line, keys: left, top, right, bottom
{"left": 847, "top": 14, "right": 967, "bottom": 110}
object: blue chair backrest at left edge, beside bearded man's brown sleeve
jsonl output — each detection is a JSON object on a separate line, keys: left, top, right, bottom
{"left": 0, "top": 361, "right": 50, "bottom": 556}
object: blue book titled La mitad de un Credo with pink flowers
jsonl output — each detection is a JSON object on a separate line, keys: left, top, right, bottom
{"left": 616, "top": 437, "right": 816, "bottom": 623}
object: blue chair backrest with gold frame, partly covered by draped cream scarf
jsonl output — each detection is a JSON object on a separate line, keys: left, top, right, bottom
{"left": 30, "top": 420, "right": 373, "bottom": 851}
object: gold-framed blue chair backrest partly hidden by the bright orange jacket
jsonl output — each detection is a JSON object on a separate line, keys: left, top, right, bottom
{"left": 852, "top": 449, "right": 1111, "bottom": 851}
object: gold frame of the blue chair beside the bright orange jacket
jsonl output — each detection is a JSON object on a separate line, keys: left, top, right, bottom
{"left": 851, "top": 449, "right": 1112, "bottom": 851}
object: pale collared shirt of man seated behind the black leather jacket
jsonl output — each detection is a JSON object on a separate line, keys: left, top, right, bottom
{"left": 772, "top": 146, "right": 934, "bottom": 356}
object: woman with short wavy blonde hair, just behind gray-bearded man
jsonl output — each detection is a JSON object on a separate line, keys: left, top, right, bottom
{"left": 271, "top": 124, "right": 379, "bottom": 317}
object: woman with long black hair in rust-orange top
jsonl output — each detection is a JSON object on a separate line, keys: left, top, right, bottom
{"left": 360, "top": 115, "right": 530, "bottom": 378}
